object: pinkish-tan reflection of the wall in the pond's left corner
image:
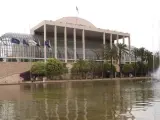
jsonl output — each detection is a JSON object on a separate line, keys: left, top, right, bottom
{"left": 0, "top": 85, "right": 32, "bottom": 120}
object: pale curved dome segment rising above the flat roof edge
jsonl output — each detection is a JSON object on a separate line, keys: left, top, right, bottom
{"left": 55, "top": 17, "right": 96, "bottom": 28}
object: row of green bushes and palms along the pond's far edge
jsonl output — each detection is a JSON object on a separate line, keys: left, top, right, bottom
{"left": 28, "top": 43, "right": 159, "bottom": 79}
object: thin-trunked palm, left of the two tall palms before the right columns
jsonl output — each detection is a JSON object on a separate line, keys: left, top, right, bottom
{"left": 104, "top": 44, "right": 118, "bottom": 77}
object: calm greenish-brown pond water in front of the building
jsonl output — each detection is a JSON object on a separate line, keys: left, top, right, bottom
{"left": 0, "top": 81, "right": 160, "bottom": 120}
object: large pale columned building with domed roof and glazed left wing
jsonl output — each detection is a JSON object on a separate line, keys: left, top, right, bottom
{"left": 0, "top": 17, "right": 131, "bottom": 63}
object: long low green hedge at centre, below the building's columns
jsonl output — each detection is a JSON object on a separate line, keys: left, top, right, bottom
{"left": 71, "top": 60, "right": 116, "bottom": 78}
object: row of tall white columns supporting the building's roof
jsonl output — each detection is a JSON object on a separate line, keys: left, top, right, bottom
{"left": 44, "top": 24, "right": 131, "bottom": 63}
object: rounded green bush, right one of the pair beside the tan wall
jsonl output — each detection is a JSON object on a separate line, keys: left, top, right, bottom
{"left": 46, "top": 59, "right": 64, "bottom": 78}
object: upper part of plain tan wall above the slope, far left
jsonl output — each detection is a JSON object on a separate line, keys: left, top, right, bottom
{"left": 0, "top": 62, "right": 31, "bottom": 79}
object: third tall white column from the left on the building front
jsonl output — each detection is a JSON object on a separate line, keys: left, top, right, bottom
{"left": 64, "top": 27, "right": 67, "bottom": 63}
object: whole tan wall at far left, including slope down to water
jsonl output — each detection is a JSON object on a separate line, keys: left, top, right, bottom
{"left": 0, "top": 62, "right": 31, "bottom": 83}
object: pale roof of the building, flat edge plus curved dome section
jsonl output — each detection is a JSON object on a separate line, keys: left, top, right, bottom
{"left": 31, "top": 17, "right": 130, "bottom": 37}
